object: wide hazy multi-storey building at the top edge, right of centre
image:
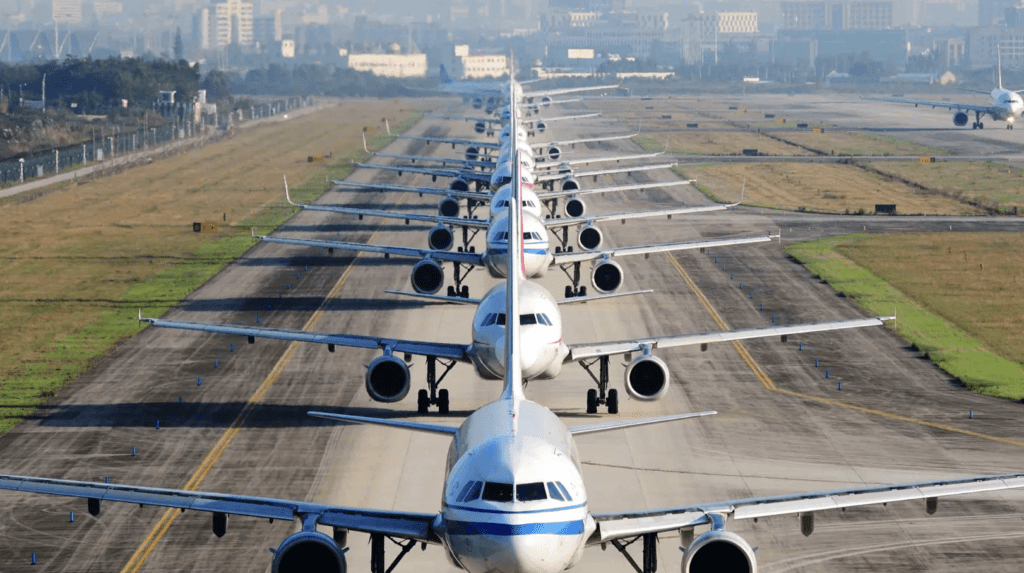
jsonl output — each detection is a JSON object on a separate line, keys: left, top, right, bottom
{"left": 779, "top": 0, "right": 893, "bottom": 30}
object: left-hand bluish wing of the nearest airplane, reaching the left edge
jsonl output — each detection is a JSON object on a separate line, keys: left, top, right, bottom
{"left": 0, "top": 475, "right": 441, "bottom": 543}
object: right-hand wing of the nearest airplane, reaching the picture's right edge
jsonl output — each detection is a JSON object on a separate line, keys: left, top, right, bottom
{"left": 587, "top": 474, "right": 1024, "bottom": 544}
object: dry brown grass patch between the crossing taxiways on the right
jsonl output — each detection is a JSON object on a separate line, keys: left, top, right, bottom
{"left": 682, "top": 163, "right": 981, "bottom": 215}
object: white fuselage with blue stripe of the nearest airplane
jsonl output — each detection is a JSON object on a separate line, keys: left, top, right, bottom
{"left": 436, "top": 399, "right": 596, "bottom": 573}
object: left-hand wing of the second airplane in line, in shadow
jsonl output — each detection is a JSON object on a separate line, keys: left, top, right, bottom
{"left": 138, "top": 314, "right": 470, "bottom": 362}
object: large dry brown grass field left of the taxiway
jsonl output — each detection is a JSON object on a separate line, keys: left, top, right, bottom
{"left": 0, "top": 100, "right": 434, "bottom": 430}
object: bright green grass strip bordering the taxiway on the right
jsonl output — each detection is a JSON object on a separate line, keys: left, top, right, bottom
{"left": 785, "top": 234, "right": 1024, "bottom": 400}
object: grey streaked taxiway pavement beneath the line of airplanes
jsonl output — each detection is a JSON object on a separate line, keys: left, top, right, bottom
{"left": 0, "top": 96, "right": 1024, "bottom": 572}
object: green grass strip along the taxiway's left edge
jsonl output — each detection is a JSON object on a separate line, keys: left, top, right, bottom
{"left": 0, "top": 109, "right": 423, "bottom": 436}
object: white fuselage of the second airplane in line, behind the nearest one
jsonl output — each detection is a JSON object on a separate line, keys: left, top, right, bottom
{"left": 472, "top": 282, "right": 568, "bottom": 380}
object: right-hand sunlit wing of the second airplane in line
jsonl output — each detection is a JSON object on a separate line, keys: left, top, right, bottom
{"left": 565, "top": 316, "right": 896, "bottom": 362}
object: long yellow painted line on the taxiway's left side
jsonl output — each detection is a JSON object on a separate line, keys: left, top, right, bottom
{"left": 121, "top": 192, "right": 409, "bottom": 573}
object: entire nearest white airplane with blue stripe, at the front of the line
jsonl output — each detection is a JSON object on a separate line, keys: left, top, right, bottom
{"left": 0, "top": 118, "right": 1024, "bottom": 573}
